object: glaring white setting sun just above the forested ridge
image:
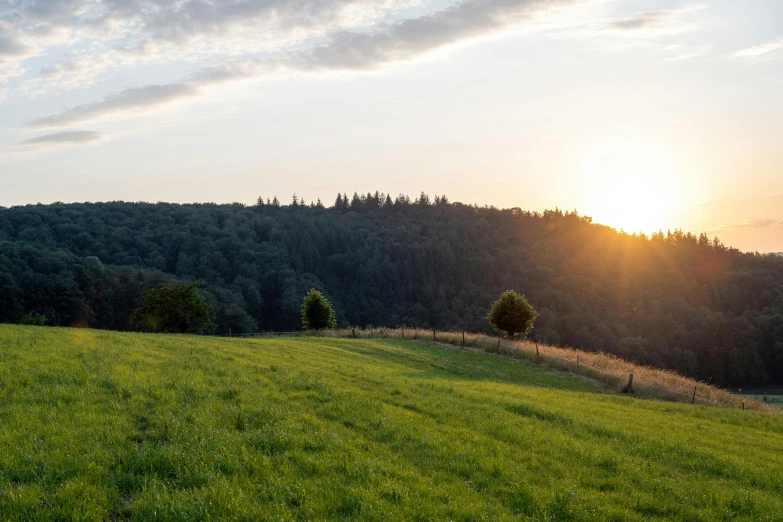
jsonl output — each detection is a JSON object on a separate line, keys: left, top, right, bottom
{"left": 584, "top": 140, "right": 679, "bottom": 234}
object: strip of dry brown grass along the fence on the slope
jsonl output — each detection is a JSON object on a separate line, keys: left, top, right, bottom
{"left": 310, "top": 328, "right": 779, "bottom": 412}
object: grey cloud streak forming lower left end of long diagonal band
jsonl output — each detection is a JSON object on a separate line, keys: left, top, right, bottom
{"left": 26, "top": 83, "right": 197, "bottom": 129}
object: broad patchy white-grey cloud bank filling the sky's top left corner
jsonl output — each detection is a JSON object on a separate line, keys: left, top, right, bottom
{"left": 0, "top": 0, "right": 424, "bottom": 89}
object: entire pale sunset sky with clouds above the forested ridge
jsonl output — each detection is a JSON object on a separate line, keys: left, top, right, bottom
{"left": 0, "top": 0, "right": 783, "bottom": 252}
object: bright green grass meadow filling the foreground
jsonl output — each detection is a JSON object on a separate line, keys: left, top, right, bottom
{"left": 0, "top": 326, "right": 783, "bottom": 521}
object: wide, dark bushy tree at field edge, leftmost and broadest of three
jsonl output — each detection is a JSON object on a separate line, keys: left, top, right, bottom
{"left": 131, "top": 281, "right": 215, "bottom": 333}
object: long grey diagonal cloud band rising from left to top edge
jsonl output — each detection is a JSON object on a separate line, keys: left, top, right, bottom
{"left": 26, "top": 0, "right": 577, "bottom": 128}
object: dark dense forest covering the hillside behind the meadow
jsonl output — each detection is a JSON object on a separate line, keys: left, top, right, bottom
{"left": 0, "top": 193, "right": 783, "bottom": 384}
